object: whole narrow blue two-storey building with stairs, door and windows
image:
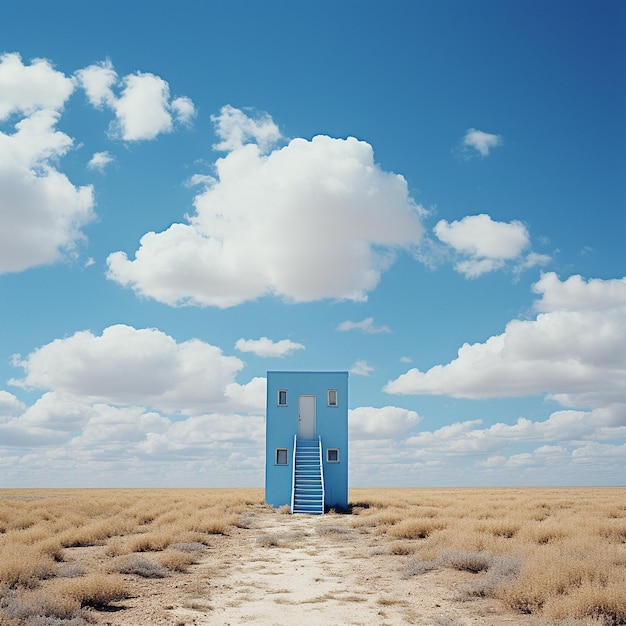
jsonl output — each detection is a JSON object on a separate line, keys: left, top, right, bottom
{"left": 265, "top": 372, "right": 348, "bottom": 513}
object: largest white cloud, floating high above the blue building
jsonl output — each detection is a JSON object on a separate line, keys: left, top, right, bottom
{"left": 108, "top": 109, "right": 423, "bottom": 307}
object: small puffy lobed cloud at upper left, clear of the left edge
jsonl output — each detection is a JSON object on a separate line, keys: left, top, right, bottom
{"left": 76, "top": 59, "right": 196, "bottom": 141}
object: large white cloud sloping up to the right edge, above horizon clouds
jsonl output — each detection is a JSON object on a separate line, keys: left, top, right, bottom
{"left": 385, "top": 273, "right": 626, "bottom": 412}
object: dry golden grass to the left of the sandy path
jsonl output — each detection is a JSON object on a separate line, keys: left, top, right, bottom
{"left": 0, "top": 489, "right": 263, "bottom": 626}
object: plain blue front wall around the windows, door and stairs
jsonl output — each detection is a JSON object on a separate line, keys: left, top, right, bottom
{"left": 265, "top": 372, "right": 348, "bottom": 508}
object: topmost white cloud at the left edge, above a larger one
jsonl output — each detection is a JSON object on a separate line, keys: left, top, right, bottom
{"left": 0, "top": 53, "right": 74, "bottom": 121}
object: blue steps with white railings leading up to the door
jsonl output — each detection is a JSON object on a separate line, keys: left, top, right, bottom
{"left": 291, "top": 437, "right": 324, "bottom": 515}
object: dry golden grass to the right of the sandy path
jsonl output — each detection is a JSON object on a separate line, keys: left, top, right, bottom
{"left": 350, "top": 487, "right": 626, "bottom": 625}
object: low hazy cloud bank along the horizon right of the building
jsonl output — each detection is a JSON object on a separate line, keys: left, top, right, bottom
{"left": 350, "top": 398, "right": 626, "bottom": 487}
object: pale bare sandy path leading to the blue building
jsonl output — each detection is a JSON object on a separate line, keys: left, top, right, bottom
{"left": 89, "top": 506, "right": 538, "bottom": 626}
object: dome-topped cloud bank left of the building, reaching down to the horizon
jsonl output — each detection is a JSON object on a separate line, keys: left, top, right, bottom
{"left": 0, "top": 325, "right": 266, "bottom": 478}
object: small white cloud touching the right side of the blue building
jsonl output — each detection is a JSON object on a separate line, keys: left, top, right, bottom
{"left": 348, "top": 406, "right": 422, "bottom": 440}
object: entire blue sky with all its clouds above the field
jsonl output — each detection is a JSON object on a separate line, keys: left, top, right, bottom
{"left": 0, "top": 0, "right": 626, "bottom": 487}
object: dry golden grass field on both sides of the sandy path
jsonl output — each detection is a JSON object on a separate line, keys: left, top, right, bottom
{"left": 0, "top": 488, "right": 626, "bottom": 626}
